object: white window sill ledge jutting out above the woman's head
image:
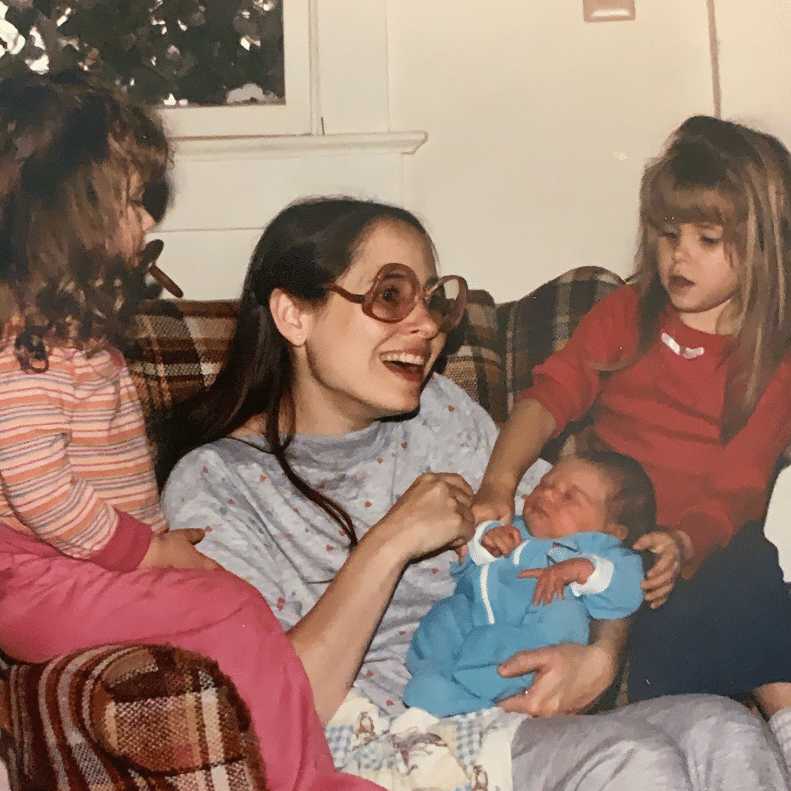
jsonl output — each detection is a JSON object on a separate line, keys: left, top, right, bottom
{"left": 174, "top": 131, "right": 428, "bottom": 162}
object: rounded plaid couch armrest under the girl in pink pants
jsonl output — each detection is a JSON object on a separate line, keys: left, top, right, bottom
{"left": 3, "top": 646, "right": 266, "bottom": 791}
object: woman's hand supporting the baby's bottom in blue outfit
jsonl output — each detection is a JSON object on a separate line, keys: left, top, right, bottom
{"left": 498, "top": 643, "right": 618, "bottom": 717}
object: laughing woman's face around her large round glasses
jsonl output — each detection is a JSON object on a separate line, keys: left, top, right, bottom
{"left": 295, "top": 221, "right": 445, "bottom": 434}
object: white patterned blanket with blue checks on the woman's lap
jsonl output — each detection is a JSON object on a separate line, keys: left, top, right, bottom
{"left": 327, "top": 689, "right": 523, "bottom": 791}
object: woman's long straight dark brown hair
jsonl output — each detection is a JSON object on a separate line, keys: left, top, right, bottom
{"left": 159, "top": 197, "right": 433, "bottom": 546}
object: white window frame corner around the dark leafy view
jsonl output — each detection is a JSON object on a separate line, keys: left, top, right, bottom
{"left": 158, "top": 0, "right": 315, "bottom": 140}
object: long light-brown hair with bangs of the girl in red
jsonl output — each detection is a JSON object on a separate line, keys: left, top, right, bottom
{"left": 635, "top": 116, "right": 791, "bottom": 442}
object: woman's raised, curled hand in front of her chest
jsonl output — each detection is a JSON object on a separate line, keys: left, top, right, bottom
{"left": 378, "top": 472, "right": 475, "bottom": 561}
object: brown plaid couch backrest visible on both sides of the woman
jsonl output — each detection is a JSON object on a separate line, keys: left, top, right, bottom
{"left": 126, "top": 267, "right": 622, "bottom": 453}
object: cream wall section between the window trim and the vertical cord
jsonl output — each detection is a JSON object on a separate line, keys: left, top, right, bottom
{"left": 388, "top": 0, "right": 713, "bottom": 299}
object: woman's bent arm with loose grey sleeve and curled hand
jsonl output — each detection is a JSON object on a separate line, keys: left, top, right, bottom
{"left": 162, "top": 445, "right": 473, "bottom": 720}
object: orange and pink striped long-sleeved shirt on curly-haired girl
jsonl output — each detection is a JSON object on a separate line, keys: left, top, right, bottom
{"left": 0, "top": 336, "right": 166, "bottom": 570}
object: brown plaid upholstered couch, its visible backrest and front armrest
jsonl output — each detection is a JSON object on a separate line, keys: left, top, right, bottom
{"left": 0, "top": 267, "right": 621, "bottom": 791}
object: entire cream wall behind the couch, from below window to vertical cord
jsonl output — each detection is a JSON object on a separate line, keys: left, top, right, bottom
{"left": 162, "top": 0, "right": 716, "bottom": 300}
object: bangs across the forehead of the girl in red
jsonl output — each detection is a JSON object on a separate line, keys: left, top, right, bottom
{"left": 642, "top": 167, "right": 741, "bottom": 231}
